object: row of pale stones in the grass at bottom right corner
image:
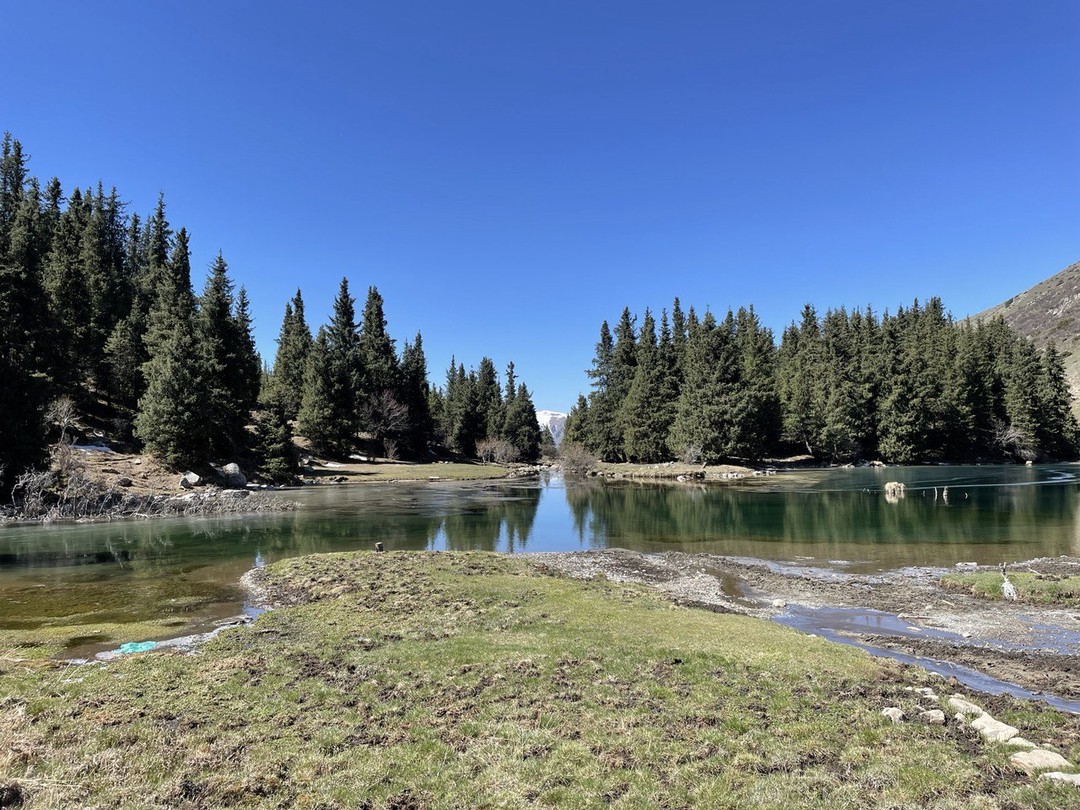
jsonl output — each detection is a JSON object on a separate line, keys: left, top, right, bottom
{"left": 881, "top": 687, "right": 1080, "bottom": 787}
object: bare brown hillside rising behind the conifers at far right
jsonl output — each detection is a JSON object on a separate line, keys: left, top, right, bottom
{"left": 972, "top": 261, "right": 1080, "bottom": 407}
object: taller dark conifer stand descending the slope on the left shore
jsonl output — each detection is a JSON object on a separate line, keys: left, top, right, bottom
{"left": 0, "top": 134, "right": 541, "bottom": 500}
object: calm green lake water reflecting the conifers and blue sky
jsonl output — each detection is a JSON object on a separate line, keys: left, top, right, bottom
{"left": 0, "top": 464, "right": 1080, "bottom": 634}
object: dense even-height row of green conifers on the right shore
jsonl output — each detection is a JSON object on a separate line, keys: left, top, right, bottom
{"left": 564, "top": 298, "right": 1080, "bottom": 463}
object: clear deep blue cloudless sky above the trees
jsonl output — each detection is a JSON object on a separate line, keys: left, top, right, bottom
{"left": 0, "top": 0, "right": 1080, "bottom": 410}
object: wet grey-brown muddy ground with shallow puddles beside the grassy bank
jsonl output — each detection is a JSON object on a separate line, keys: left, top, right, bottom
{"left": 534, "top": 549, "right": 1080, "bottom": 701}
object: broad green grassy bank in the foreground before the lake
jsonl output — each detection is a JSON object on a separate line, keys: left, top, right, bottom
{"left": 0, "top": 553, "right": 1080, "bottom": 809}
